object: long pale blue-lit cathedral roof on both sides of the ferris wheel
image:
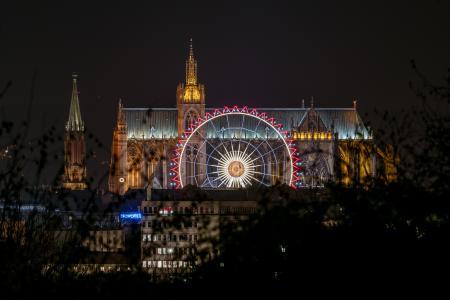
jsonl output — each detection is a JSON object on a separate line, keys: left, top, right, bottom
{"left": 123, "top": 108, "right": 371, "bottom": 139}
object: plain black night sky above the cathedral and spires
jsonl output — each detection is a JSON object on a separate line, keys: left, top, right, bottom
{"left": 0, "top": 0, "right": 450, "bottom": 183}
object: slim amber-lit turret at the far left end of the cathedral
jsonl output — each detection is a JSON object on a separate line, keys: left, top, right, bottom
{"left": 108, "top": 100, "right": 128, "bottom": 195}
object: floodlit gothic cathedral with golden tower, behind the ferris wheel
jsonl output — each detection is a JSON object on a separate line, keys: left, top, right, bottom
{"left": 109, "top": 41, "right": 377, "bottom": 194}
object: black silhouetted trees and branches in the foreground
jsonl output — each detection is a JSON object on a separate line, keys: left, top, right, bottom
{"left": 0, "top": 65, "right": 450, "bottom": 298}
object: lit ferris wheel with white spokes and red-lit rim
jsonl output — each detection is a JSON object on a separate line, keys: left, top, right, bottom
{"left": 170, "top": 106, "right": 299, "bottom": 188}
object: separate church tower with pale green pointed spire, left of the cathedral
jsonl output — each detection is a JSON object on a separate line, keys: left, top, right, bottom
{"left": 63, "top": 74, "right": 87, "bottom": 190}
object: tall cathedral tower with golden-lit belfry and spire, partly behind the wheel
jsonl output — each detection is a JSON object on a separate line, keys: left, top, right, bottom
{"left": 177, "top": 39, "right": 206, "bottom": 185}
